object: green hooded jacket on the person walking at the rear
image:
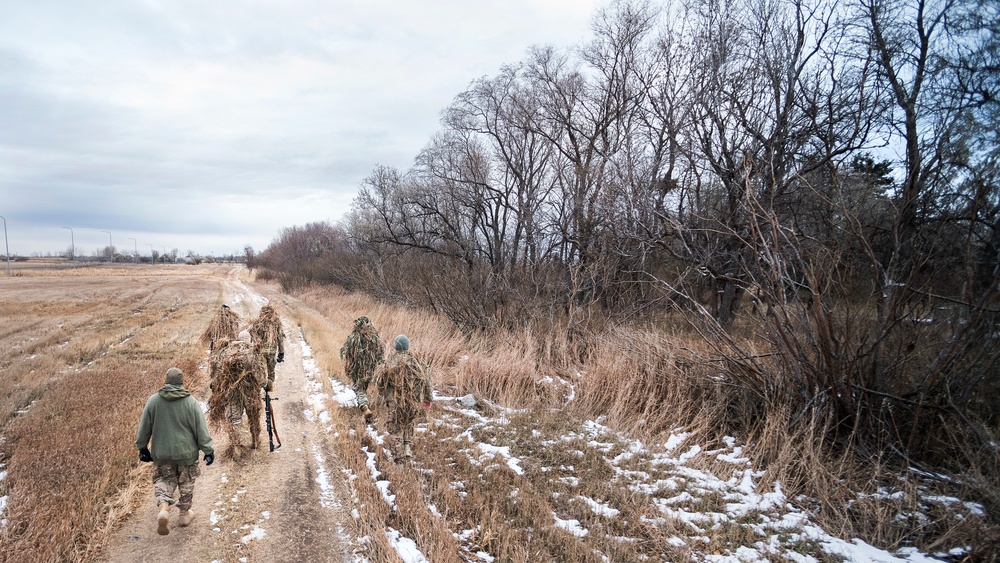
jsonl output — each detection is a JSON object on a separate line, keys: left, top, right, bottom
{"left": 135, "top": 383, "right": 215, "bottom": 465}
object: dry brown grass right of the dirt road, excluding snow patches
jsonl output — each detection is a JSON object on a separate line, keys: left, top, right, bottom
{"left": 288, "top": 288, "right": 995, "bottom": 561}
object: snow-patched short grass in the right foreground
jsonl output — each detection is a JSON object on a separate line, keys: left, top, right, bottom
{"left": 322, "top": 381, "right": 983, "bottom": 563}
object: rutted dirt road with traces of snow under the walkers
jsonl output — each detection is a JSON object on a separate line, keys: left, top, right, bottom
{"left": 99, "top": 268, "right": 353, "bottom": 563}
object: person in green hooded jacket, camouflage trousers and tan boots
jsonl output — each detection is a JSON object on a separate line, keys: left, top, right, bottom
{"left": 135, "top": 368, "right": 215, "bottom": 536}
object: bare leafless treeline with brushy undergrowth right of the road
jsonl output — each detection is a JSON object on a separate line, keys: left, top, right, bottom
{"left": 254, "top": 0, "right": 1000, "bottom": 484}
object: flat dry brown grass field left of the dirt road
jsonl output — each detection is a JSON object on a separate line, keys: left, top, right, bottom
{"left": 0, "top": 267, "right": 227, "bottom": 561}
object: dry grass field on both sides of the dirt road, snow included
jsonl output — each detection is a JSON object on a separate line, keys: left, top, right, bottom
{"left": 0, "top": 265, "right": 997, "bottom": 563}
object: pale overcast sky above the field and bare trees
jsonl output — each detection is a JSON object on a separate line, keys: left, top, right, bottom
{"left": 0, "top": 0, "right": 604, "bottom": 256}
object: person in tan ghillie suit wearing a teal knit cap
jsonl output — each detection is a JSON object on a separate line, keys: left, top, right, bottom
{"left": 372, "top": 334, "right": 433, "bottom": 461}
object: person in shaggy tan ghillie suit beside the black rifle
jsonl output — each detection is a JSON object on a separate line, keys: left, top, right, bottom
{"left": 208, "top": 333, "right": 267, "bottom": 458}
